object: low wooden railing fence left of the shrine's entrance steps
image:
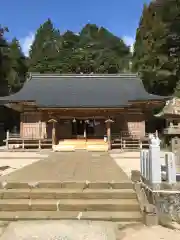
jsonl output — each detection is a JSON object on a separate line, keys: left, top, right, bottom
{"left": 4, "top": 131, "right": 52, "bottom": 149}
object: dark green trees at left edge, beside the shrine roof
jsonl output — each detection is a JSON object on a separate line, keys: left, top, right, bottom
{"left": 0, "top": 27, "right": 28, "bottom": 96}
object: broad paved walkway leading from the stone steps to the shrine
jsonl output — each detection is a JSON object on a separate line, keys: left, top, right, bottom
{"left": 0, "top": 151, "right": 128, "bottom": 182}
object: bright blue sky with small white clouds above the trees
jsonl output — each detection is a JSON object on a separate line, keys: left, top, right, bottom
{"left": 0, "top": 0, "right": 150, "bottom": 54}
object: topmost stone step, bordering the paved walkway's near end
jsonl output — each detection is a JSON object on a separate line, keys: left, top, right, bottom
{"left": 0, "top": 181, "right": 133, "bottom": 189}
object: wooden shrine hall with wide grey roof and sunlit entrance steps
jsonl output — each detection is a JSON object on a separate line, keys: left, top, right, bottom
{"left": 0, "top": 74, "right": 167, "bottom": 150}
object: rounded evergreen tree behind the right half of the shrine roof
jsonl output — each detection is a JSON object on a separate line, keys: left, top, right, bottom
{"left": 77, "top": 24, "right": 130, "bottom": 73}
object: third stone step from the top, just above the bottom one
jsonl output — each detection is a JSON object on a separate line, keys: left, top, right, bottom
{"left": 0, "top": 199, "right": 140, "bottom": 211}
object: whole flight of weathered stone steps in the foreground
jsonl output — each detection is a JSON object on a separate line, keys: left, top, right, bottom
{"left": 0, "top": 182, "right": 142, "bottom": 222}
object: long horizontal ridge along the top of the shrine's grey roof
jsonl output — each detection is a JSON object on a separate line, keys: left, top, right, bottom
{"left": 29, "top": 73, "right": 139, "bottom": 79}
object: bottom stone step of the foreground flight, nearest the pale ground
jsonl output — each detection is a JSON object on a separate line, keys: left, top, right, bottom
{"left": 0, "top": 211, "right": 142, "bottom": 222}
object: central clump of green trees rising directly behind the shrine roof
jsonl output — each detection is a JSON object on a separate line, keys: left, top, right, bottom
{"left": 29, "top": 19, "right": 131, "bottom": 73}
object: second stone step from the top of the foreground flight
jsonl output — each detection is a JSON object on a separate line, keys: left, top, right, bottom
{"left": 0, "top": 188, "right": 136, "bottom": 199}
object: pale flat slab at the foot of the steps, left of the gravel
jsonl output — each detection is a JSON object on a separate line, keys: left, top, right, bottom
{"left": 0, "top": 221, "right": 116, "bottom": 240}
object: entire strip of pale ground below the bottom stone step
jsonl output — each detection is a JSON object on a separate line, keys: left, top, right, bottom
{"left": 0, "top": 221, "right": 180, "bottom": 240}
